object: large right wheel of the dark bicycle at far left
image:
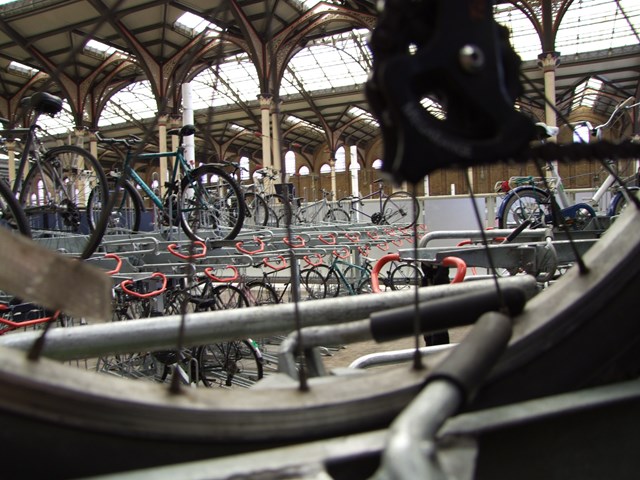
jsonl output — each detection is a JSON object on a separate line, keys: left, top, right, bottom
{"left": 20, "top": 145, "right": 108, "bottom": 258}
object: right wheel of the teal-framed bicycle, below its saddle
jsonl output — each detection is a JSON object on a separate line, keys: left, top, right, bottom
{"left": 178, "top": 165, "right": 246, "bottom": 242}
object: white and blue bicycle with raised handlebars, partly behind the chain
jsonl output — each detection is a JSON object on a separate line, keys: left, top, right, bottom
{"left": 495, "top": 97, "right": 639, "bottom": 230}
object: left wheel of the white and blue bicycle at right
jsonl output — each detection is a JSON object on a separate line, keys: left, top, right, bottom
{"left": 498, "top": 187, "right": 551, "bottom": 228}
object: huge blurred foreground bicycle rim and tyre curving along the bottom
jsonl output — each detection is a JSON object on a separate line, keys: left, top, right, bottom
{"left": 0, "top": 209, "right": 640, "bottom": 476}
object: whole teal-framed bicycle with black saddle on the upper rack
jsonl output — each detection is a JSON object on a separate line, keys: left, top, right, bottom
{"left": 89, "top": 125, "right": 246, "bottom": 241}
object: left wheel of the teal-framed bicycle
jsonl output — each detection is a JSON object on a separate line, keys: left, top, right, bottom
{"left": 87, "top": 178, "right": 143, "bottom": 235}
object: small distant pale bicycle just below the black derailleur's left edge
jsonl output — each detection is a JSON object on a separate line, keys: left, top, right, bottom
{"left": 338, "top": 179, "right": 420, "bottom": 227}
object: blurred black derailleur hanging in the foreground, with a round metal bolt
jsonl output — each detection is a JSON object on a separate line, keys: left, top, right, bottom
{"left": 365, "top": 0, "right": 535, "bottom": 183}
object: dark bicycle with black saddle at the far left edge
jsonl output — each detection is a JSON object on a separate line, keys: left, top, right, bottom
{"left": 0, "top": 92, "right": 108, "bottom": 258}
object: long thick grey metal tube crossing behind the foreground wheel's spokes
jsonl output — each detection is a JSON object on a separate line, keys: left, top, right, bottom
{"left": 0, "top": 276, "right": 537, "bottom": 360}
